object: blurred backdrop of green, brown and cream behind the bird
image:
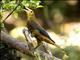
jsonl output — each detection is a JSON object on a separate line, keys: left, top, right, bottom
{"left": 0, "top": 0, "right": 80, "bottom": 60}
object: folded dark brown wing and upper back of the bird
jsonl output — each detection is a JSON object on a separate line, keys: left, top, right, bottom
{"left": 28, "top": 20, "right": 55, "bottom": 43}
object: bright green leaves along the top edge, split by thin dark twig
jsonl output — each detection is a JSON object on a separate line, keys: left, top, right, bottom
{"left": 2, "top": 0, "right": 42, "bottom": 10}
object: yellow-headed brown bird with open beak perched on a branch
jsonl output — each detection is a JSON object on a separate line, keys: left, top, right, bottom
{"left": 25, "top": 8, "right": 61, "bottom": 49}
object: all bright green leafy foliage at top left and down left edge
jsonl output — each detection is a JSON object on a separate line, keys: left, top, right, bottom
{"left": 0, "top": 0, "right": 43, "bottom": 30}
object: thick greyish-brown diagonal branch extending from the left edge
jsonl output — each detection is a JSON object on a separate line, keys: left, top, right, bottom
{"left": 0, "top": 31, "right": 34, "bottom": 56}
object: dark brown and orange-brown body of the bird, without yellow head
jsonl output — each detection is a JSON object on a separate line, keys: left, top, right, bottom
{"left": 27, "top": 20, "right": 55, "bottom": 45}
